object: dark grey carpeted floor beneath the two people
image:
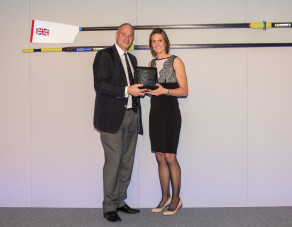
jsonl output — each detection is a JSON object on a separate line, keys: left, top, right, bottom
{"left": 0, "top": 207, "right": 292, "bottom": 227}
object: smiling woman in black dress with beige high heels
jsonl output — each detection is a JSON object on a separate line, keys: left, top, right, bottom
{"left": 147, "top": 28, "right": 188, "bottom": 215}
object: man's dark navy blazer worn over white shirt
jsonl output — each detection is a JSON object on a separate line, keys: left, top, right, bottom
{"left": 93, "top": 45, "right": 143, "bottom": 134}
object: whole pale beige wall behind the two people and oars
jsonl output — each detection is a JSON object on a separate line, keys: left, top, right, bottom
{"left": 0, "top": 0, "right": 292, "bottom": 207}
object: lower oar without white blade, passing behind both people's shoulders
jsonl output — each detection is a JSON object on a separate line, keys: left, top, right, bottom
{"left": 22, "top": 43, "right": 292, "bottom": 53}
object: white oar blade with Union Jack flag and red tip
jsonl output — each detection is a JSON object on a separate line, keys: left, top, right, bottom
{"left": 30, "top": 20, "right": 79, "bottom": 43}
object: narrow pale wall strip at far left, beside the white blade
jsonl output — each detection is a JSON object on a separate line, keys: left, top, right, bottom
{"left": 0, "top": 0, "right": 31, "bottom": 207}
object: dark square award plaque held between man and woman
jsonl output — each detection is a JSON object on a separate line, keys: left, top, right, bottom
{"left": 135, "top": 66, "right": 158, "bottom": 90}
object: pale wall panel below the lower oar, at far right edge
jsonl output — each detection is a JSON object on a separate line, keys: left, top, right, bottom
{"left": 248, "top": 48, "right": 292, "bottom": 206}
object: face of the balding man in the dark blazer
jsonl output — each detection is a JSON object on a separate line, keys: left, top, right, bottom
{"left": 116, "top": 25, "right": 134, "bottom": 52}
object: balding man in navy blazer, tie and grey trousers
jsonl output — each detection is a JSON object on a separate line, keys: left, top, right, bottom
{"left": 93, "top": 23, "right": 145, "bottom": 221}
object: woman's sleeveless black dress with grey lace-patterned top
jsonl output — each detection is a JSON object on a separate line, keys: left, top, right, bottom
{"left": 149, "top": 55, "right": 181, "bottom": 154}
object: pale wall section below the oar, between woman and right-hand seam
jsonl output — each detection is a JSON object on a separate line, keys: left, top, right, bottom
{"left": 179, "top": 49, "right": 247, "bottom": 206}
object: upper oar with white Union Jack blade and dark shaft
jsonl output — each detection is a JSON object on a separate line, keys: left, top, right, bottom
{"left": 30, "top": 20, "right": 292, "bottom": 43}
